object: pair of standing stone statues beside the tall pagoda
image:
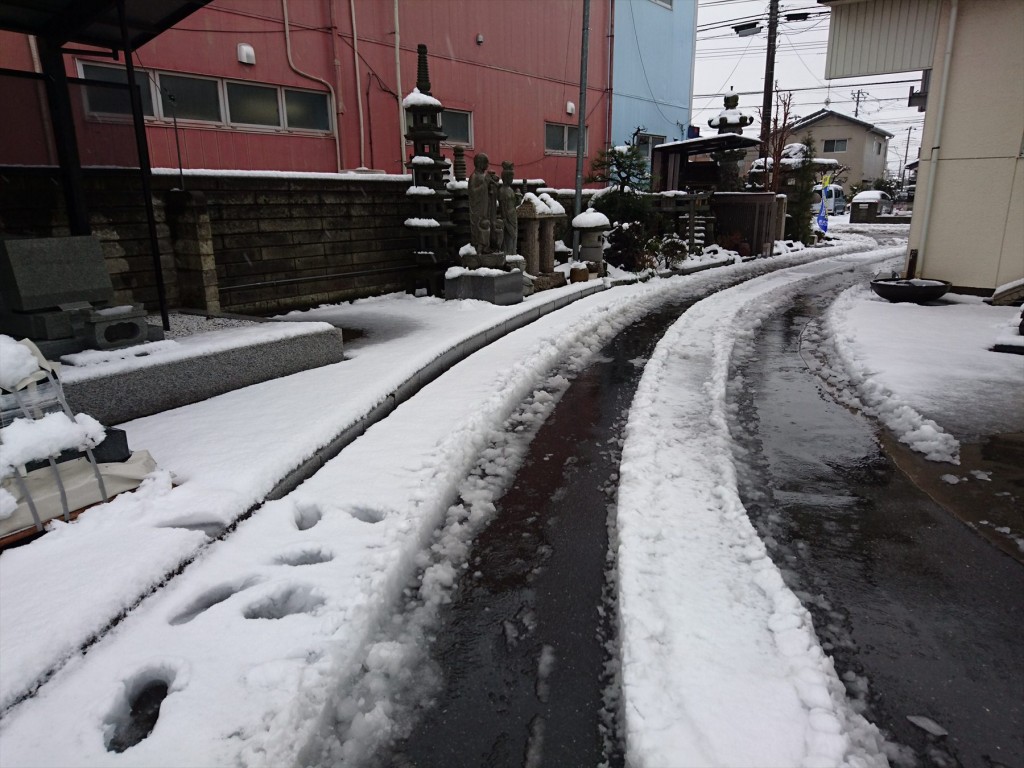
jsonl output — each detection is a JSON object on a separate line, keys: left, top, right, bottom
{"left": 469, "top": 153, "right": 519, "bottom": 255}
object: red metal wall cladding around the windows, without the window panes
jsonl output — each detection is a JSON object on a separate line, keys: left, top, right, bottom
{"left": 0, "top": 0, "right": 610, "bottom": 187}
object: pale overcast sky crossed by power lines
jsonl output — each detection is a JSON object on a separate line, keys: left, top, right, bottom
{"left": 692, "top": 0, "right": 925, "bottom": 175}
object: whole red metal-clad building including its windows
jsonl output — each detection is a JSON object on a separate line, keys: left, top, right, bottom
{"left": 0, "top": 0, "right": 611, "bottom": 186}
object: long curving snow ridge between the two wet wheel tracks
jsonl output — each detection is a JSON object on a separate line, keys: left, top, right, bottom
{"left": 617, "top": 250, "right": 887, "bottom": 768}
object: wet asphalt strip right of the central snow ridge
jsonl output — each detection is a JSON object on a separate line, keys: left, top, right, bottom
{"left": 735, "top": 268, "right": 1024, "bottom": 768}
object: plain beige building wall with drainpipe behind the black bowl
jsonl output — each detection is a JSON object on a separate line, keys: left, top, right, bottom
{"left": 907, "top": 0, "right": 1024, "bottom": 293}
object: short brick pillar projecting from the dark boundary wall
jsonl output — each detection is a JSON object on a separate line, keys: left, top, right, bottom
{"left": 166, "top": 189, "right": 220, "bottom": 312}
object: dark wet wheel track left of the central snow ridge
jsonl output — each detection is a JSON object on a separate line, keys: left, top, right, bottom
{"left": 391, "top": 304, "right": 685, "bottom": 768}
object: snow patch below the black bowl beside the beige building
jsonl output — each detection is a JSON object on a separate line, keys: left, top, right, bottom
{"left": 827, "top": 285, "right": 1024, "bottom": 456}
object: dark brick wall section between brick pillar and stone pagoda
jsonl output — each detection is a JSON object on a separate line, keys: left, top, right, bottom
{"left": 178, "top": 176, "right": 416, "bottom": 313}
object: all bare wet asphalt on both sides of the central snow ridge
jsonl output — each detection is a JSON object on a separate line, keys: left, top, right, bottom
{"left": 386, "top": 259, "right": 1024, "bottom": 768}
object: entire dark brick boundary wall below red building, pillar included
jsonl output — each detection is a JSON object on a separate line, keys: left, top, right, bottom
{"left": 0, "top": 168, "right": 416, "bottom": 313}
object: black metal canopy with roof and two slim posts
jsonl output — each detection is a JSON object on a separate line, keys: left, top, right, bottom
{"left": 0, "top": 0, "right": 210, "bottom": 331}
